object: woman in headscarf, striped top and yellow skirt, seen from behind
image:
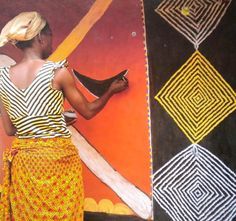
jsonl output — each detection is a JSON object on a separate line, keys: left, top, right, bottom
{"left": 0, "top": 12, "right": 128, "bottom": 221}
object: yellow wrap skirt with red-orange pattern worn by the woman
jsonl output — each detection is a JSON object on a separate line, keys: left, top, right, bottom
{"left": 0, "top": 138, "right": 84, "bottom": 221}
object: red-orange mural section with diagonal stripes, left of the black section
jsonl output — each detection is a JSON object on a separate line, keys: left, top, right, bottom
{"left": 0, "top": 0, "right": 152, "bottom": 218}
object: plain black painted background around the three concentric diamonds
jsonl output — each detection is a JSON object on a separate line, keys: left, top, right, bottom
{"left": 144, "top": 0, "right": 236, "bottom": 221}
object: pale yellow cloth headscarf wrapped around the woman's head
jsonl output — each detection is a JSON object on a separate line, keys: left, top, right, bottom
{"left": 0, "top": 11, "right": 46, "bottom": 47}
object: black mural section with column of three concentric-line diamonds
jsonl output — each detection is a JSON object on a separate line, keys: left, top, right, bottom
{"left": 145, "top": 0, "right": 236, "bottom": 221}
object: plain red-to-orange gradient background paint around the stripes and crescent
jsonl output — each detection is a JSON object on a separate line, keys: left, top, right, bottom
{"left": 0, "top": 0, "right": 151, "bottom": 203}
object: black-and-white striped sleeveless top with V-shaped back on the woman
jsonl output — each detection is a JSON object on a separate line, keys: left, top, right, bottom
{"left": 0, "top": 60, "right": 71, "bottom": 138}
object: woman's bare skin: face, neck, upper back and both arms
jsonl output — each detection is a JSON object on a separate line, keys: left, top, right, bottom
{"left": 0, "top": 26, "right": 128, "bottom": 136}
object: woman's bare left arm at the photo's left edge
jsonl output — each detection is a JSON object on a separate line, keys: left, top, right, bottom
{"left": 0, "top": 100, "right": 16, "bottom": 136}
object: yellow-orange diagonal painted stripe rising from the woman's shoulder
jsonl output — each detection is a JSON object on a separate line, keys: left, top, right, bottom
{"left": 48, "top": 0, "right": 112, "bottom": 61}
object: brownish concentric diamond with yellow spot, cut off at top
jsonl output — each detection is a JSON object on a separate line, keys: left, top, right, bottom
{"left": 155, "top": 0, "right": 231, "bottom": 49}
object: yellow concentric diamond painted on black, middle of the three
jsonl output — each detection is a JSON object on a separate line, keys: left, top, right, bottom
{"left": 155, "top": 51, "right": 236, "bottom": 143}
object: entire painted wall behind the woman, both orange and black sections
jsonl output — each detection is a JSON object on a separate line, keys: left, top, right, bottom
{"left": 0, "top": 0, "right": 236, "bottom": 221}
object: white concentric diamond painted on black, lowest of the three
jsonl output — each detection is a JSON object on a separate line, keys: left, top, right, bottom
{"left": 153, "top": 144, "right": 236, "bottom": 221}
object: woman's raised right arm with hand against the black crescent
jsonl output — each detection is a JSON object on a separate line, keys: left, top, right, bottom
{"left": 54, "top": 68, "right": 128, "bottom": 119}
